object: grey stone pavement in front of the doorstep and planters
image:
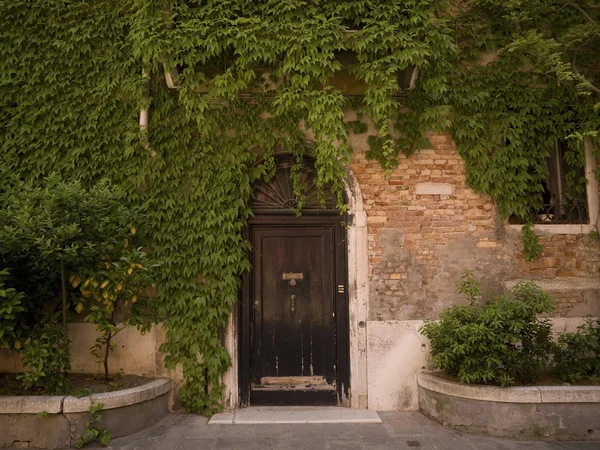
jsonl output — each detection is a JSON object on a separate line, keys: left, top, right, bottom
{"left": 86, "top": 411, "right": 600, "bottom": 450}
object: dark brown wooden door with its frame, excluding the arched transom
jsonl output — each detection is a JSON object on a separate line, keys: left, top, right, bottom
{"left": 241, "top": 216, "right": 348, "bottom": 405}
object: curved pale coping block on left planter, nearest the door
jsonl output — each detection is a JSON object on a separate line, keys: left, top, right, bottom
{"left": 62, "top": 378, "right": 171, "bottom": 413}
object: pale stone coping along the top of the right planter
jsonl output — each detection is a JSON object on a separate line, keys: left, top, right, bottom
{"left": 417, "top": 373, "right": 600, "bottom": 403}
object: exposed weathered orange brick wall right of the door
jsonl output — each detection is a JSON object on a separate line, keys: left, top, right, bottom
{"left": 350, "top": 135, "right": 600, "bottom": 320}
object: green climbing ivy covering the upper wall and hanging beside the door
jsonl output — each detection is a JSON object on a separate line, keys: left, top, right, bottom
{"left": 0, "top": 0, "right": 600, "bottom": 414}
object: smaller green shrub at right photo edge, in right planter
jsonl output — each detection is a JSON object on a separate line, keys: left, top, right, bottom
{"left": 554, "top": 319, "right": 600, "bottom": 383}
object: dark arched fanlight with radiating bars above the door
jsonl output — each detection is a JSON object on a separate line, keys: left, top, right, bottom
{"left": 251, "top": 155, "right": 336, "bottom": 214}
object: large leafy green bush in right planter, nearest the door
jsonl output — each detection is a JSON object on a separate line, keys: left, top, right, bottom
{"left": 421, "top": 279, "right": 554, "bottom": 386}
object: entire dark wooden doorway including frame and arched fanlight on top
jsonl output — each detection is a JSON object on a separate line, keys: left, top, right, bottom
{"left": 238, "top": 155, "right": 350, "bottom": 405}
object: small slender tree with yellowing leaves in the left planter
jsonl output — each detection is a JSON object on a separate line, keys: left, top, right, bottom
{"left": 70, "top": 248, "right": 156, "bottom": 379}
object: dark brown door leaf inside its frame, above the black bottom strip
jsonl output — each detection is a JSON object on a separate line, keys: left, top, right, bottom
{"left": 252, "top": 226, "right": 335, "bottom": 386}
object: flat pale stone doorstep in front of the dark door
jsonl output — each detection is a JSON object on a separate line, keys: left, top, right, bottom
{"left": 208, "top": 406, "right": 382, "bottom": 425}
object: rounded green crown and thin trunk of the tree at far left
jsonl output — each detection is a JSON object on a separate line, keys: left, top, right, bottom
{"left": 0, "top": 175, "right": 135, "bottom": 353}
